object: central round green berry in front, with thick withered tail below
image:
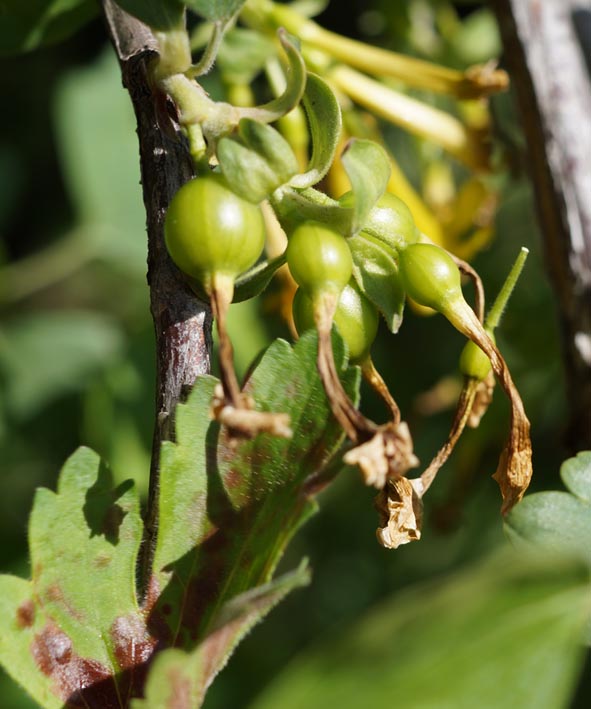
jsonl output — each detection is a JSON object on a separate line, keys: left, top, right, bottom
{"left": 286, "top": 221, "right": 353, "bottom": 297}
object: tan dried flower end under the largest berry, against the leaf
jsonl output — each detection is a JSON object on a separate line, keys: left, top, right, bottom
{"left": 211, "top": 384, "right": 293, "bottom": 438}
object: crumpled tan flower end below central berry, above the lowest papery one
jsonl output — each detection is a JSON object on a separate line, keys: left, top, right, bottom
{"left": 343, "top": 421, "right": 419, "bottom": 490}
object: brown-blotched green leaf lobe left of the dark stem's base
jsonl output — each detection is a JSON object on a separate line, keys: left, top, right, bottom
{"left": 0, "top": 448, "right": 145, "bottom": 707}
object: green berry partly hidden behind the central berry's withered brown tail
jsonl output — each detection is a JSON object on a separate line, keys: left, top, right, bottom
{"left": 292, "top": 280, "right": 379, "bottom": 364}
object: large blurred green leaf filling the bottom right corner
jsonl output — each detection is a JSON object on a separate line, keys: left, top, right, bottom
{"left": 251, "top": 555, "right": 589, "bottom": 709}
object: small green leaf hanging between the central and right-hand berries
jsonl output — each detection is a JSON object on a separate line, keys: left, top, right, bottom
{"left": 348, "top": 232, "right": 405, "bottom": 333}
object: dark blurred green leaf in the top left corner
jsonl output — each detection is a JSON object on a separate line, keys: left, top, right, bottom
{"left": 0, "top": 0, "right": 98, "bottom": 55}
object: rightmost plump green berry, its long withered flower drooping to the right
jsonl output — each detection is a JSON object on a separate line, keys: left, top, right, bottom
{"left": 398, "top": 244, "right": 464, "bottom": 315}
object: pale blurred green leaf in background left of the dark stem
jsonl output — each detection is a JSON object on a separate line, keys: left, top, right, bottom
{"left": 54, "top": 49, "right": 146, "bottom": 272}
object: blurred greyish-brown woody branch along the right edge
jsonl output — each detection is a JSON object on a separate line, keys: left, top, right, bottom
{"left": 493, "top": 0, "right": 591, "bottom": 450}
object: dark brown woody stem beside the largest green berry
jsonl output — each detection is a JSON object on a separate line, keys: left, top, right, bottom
{"left": 103, "top": 0, "right": 211, "bottom": 590}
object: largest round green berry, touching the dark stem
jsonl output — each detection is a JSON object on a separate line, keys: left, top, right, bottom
{"left": 164, "top": 173, "right": 265, "bottom": 292}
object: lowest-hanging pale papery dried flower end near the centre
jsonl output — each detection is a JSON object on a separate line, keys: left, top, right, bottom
{"left": 376, "top": 477, "right": 423, "bottom": 549}
